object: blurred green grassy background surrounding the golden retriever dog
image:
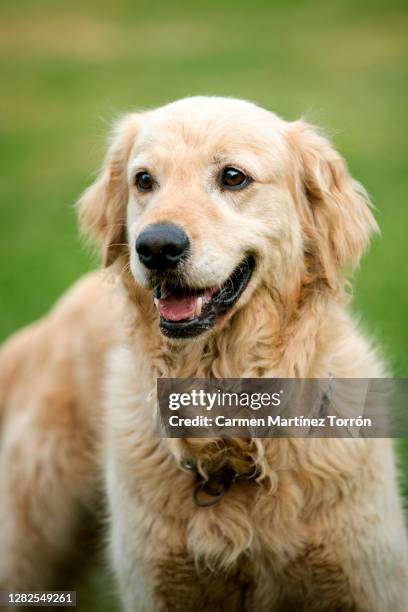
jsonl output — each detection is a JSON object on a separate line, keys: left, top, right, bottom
{"left": 0, "top": 0, "right": 408, "bottom": 610}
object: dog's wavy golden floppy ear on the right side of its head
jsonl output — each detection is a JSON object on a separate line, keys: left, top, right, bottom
{"left": 288, "top": 121, "right": 378, "bottom": 288}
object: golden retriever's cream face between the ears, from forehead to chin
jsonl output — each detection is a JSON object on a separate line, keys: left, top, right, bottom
{"left": 127, "top": 99, "right": 294, "bottom": 337}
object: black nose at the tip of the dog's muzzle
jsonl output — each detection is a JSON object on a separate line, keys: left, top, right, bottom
{"left": 136, "top": 223, "right": 190, "bottom": 270}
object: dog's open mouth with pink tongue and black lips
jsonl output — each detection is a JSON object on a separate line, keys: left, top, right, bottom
{"left": 153, "top": 255, "right": 255, "bottom": 338}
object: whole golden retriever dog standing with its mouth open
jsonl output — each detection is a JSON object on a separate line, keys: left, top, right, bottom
{"left": 0, "top": 97, "right": 408, "bottom": 612}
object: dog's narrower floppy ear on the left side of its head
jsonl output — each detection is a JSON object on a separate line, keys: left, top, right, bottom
{"left": 78, "top": 114, "right": 139, "bottom": 266}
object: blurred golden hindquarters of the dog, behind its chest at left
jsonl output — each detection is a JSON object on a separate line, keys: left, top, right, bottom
{"left": 0, "top": 272, "right": 121, "bottom": 590}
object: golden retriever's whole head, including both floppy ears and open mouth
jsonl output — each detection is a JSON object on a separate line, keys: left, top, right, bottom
{"left": 80, "top": 97, "right": 376, "bottom": 338}
